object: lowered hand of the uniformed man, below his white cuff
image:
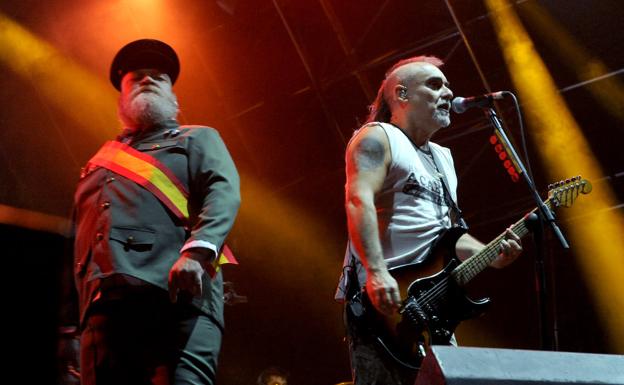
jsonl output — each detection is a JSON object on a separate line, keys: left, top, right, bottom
{"left": 169, "top": 249, "right": 206, "bottom": 302}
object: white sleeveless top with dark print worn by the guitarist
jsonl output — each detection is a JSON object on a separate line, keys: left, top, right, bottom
{"left": 354, "top": 123, "right": 457, "bottom": 267}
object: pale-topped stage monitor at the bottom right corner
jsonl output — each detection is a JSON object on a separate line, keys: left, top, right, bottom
{"left": 415, "top": 346, "right": 624, "bottom": 385}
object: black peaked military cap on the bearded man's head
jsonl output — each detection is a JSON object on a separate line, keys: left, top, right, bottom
{"left": 110, "top": 39, "right": 180, "bottom": 91}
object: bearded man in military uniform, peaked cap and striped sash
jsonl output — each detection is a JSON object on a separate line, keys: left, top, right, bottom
{"left": 74, "top": 39, "right": 240, "bottom": 385}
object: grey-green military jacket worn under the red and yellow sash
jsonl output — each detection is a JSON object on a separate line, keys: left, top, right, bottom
{"left": 74, "top": 121, "right": 240, "bottom": 326}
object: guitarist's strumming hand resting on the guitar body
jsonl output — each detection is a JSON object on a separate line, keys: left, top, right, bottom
{"left": 366, "top": 269, "right": 401, "bottom": 315}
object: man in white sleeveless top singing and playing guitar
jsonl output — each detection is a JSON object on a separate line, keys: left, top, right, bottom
{"left": 336, "top": 56, "right": 522, "bottom": 385}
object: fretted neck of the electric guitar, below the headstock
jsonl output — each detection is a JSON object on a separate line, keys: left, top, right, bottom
{"left": 451, "top": 198, "right": 552, "bottom": 285}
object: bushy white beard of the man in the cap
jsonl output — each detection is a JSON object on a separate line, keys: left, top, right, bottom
{"left": 119, "top": 92, "right": 178, "bottom": 129}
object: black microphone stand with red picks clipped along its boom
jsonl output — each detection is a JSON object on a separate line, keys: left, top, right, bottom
{"left": 486, "top": 107, "right": 570, "bottom": 350}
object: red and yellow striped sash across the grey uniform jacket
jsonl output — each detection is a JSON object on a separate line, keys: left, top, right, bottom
{"left": 89, "top": 141, "right": 238, "bottom": 276}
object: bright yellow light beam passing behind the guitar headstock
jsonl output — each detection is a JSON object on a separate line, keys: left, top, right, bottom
{"left": 485, "top": 0, "right": 624, "bottom": 353}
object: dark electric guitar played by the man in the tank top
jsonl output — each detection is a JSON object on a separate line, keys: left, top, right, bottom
{"left": 364, "top": 176, "right": 592, "bottom": 369}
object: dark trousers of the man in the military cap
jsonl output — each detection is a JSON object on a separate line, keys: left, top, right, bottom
{"left": 80, "top": 289, "right": 222, "bottom": 385}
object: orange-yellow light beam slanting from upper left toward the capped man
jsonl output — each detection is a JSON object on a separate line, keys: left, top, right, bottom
{"left": 0, "top": 13, "right": 119, "bottom": 139}
